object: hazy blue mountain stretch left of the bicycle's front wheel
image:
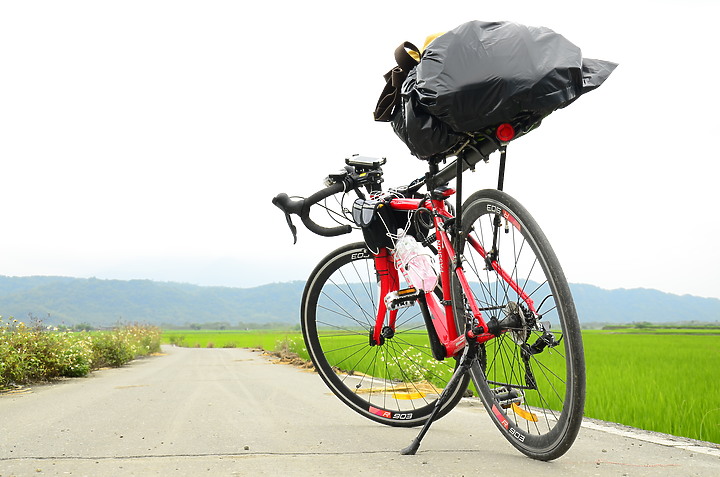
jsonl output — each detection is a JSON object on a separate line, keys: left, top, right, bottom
{"left": 0, "top": 276, "right": 305, "bottom": 325}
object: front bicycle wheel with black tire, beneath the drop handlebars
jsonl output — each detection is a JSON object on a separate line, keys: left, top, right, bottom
{"left": 301, "top": 242, "right": 469, "bottom": 427}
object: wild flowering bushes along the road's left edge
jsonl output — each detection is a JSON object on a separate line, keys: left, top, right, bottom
{"left": 0, "top": 318, "right": 161, "bottom": 390}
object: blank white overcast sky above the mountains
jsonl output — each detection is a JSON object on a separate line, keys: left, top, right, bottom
{"left": 0, "top": 0, "right": 720, "bottom": 297}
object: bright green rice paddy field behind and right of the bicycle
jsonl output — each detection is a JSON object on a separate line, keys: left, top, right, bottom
{"left": 163, "top": 330, "right": 720, "bottom": 443}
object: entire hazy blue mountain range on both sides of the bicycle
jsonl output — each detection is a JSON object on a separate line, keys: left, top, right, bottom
{"left": 0, "top": 275, "right": 720, "bottom": 326}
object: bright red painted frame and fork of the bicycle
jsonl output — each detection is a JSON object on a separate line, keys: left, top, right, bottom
{"left": 372, "top": 189, "right": 537, "bottom": 357}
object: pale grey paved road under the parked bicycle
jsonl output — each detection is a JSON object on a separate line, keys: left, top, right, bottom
{"left": 0, "top": 348, "right": 720, "bottom": 477}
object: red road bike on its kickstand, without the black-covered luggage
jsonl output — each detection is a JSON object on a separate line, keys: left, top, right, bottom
{"left": 273, "top": 129, "right": 585, "bottom": 460}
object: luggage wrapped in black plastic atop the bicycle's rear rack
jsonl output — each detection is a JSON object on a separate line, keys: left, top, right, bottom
{"left": 375, "top": 21, "right": 617, "bottom": 159}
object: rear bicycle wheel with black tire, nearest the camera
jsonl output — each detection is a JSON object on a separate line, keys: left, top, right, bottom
{"left": 452, "top": 190, "right": 585, "bottom": 461}
